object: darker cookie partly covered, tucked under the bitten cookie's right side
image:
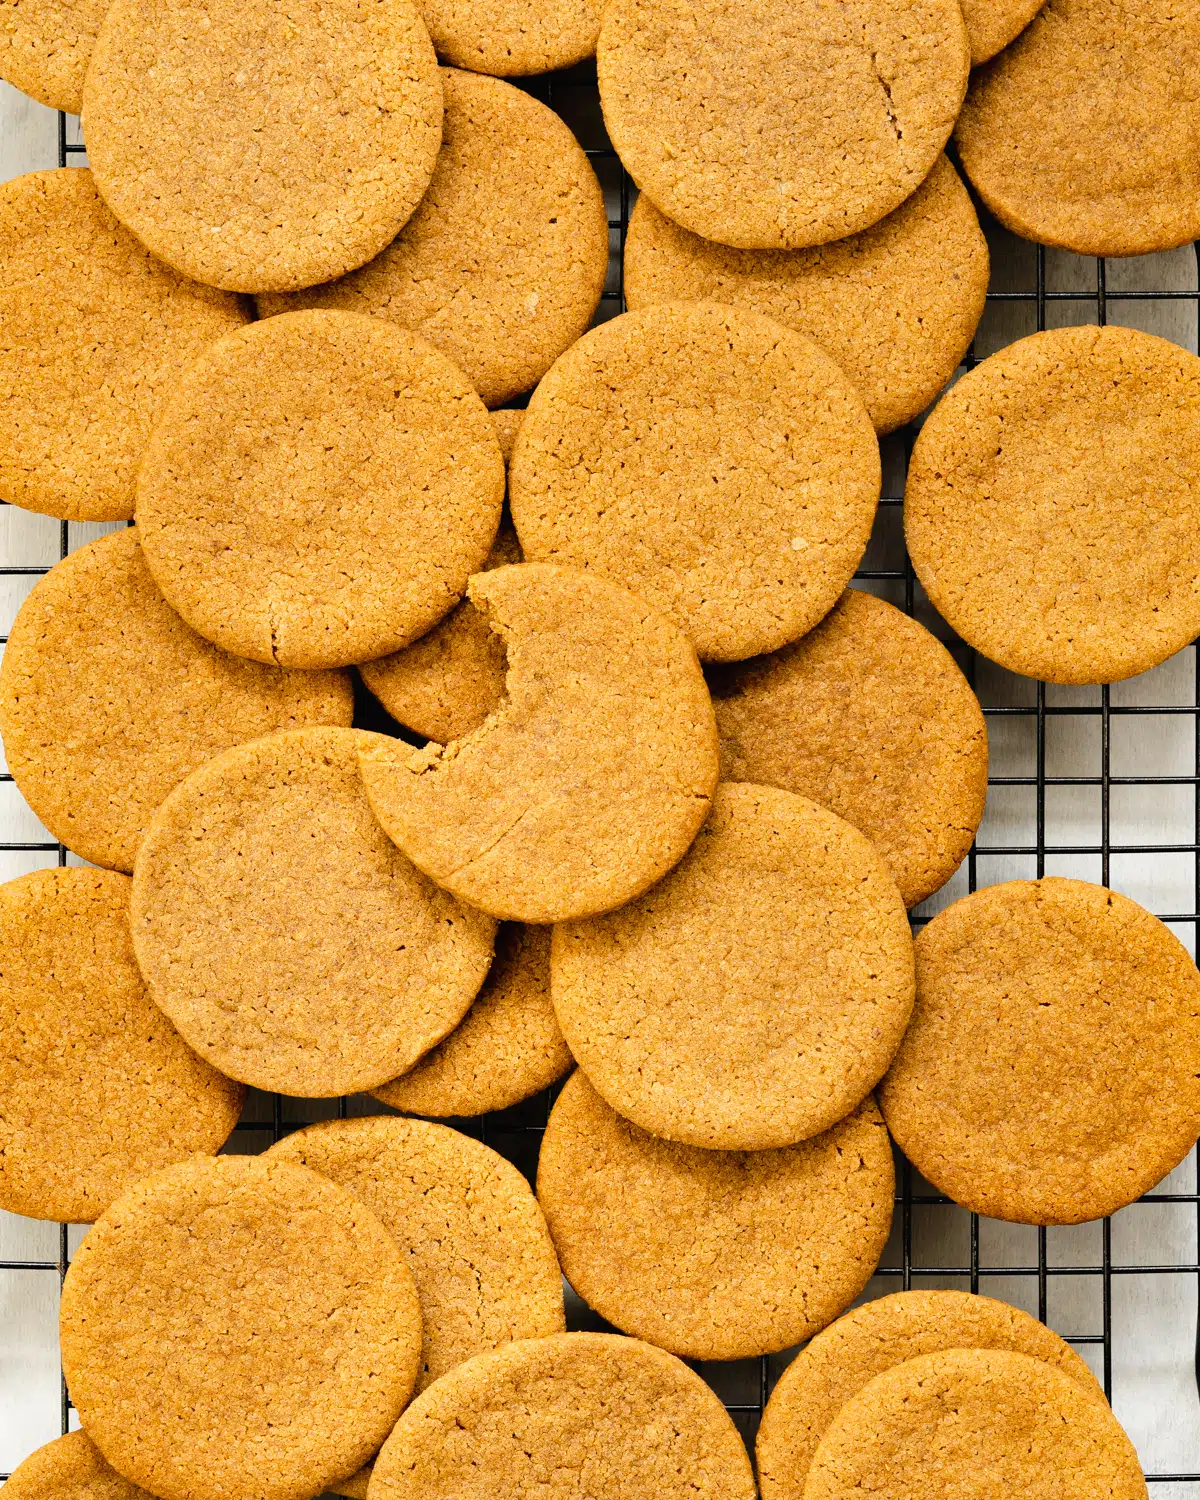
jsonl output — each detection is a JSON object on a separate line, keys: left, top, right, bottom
{"left": 708, "top": 588, "right": 987, "bottom": 906}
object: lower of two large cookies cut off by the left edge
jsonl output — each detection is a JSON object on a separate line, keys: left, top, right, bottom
{"left": 0, "top": 869, "right": 245, "bottom": 1224}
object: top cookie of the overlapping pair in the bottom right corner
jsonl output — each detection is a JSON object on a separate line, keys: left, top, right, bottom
{"left": 804, "top": 1349, "right": 1146, "bottom": 1500}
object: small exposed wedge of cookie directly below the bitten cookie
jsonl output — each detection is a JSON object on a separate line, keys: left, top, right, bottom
{"left": 374, "top": 923, "right": 572, "bottom": 1116}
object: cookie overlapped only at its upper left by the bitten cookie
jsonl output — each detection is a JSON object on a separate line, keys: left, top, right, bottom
{"left": 551, "top": 782, "right": 912, "bottom": 1151}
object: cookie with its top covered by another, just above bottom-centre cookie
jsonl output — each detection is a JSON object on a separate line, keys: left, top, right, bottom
{"left": 537, "top": 1073, "right": 896, "bottom": 1359}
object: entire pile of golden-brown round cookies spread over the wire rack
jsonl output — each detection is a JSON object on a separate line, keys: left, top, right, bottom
{"left": 0, "top": 0, "right": 1200, "bottom": 1500}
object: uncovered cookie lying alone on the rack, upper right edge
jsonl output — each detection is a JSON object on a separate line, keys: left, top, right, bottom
{"left": 905, "top": 329, "right": 1200, "bottom": 683}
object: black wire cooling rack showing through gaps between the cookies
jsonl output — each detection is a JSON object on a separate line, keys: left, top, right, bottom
{"left": 0, "top": 66, "right": 1200, "bottom": 1500}
